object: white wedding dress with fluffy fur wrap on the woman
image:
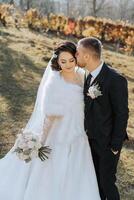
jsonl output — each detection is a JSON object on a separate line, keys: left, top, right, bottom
{"left": 0, "top": 67, "right": 100, "bottom": 200}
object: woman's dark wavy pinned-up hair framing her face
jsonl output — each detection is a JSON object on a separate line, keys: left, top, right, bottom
{"left": 51, "top": 41, "right": 76, "bottom": 71}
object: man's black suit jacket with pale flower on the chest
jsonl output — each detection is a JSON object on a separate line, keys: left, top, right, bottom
{"left": 84, "top": 63, "right": 129, "bottom": 150}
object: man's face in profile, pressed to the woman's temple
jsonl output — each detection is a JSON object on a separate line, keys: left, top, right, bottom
{"left": 76, "top": 43, "right": 86, "bottom": 68}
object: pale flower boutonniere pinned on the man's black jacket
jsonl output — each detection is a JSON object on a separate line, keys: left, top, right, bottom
{"left": 87, "top": 83, "right": 102, "bottom": 99}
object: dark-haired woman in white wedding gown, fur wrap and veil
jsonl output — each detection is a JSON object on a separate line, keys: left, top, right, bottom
{"left": 0, "top": 42, "right": 100, "bottom": 200}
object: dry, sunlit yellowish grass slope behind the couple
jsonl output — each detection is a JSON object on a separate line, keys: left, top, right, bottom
{"left": 0, "top": 28, "right": 134, "bottom": 200}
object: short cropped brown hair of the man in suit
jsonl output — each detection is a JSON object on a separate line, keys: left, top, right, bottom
{"left": 79, "top": 37, "right": 102, "bottom": 59}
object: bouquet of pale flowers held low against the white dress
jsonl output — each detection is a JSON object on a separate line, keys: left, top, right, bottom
{"left": 13, "top": 129, "right": 51, "bottom": 163}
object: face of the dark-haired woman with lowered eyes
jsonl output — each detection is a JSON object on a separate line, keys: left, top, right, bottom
{"left": 58, "top": 52, "right": 76, "bottom": 72}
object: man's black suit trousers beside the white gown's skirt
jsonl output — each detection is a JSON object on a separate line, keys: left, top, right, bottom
{"left": 89, "top": 139, "right": 120, "bottom": 200}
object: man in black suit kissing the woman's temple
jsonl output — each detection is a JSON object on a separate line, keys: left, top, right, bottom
{"left": 76, "top": 37, "right": 129, "bottom": 200}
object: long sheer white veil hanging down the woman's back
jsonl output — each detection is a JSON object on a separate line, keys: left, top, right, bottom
{"left": 23, "top": 60, "right": 54, "bottom": 135}
